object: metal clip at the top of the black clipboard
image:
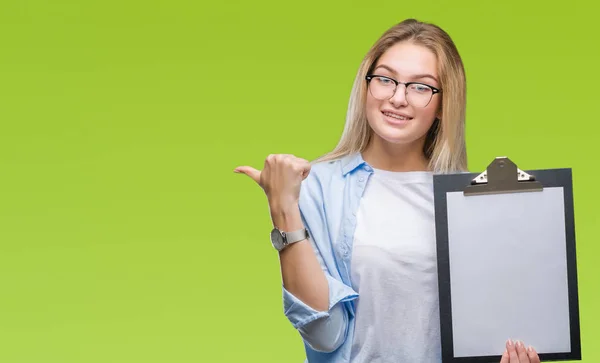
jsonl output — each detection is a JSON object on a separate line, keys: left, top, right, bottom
{"left": 464, "top": 156, "right": 544, "bottom": 195}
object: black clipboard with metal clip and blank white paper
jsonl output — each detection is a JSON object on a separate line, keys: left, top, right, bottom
{"left": 433, "top": 157, "right": 581, "bottom": 363}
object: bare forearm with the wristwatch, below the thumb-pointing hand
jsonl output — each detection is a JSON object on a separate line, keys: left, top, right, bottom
{"left": 271, "top": 205, "right": 329, "bottom": 311}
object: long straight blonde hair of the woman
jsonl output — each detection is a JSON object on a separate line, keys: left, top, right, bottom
{"left": 315, "top": 19, "right": 467, "bottom": 173}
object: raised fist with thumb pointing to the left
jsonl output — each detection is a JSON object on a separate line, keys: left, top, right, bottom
{"left": 234, "top": 154, "right": 310, "bottom": 209}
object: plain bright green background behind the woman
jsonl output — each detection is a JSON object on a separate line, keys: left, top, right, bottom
{"left": 0, "top": 0, "right": 600, "bottom": 363}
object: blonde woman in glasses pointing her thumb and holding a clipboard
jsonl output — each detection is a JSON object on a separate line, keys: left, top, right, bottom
{"left": 235, "top": 19, "right": 539, "bottom": 363}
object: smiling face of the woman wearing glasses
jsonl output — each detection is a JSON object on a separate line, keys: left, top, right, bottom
{"left": 366, "top": 42, "right": 441, "bottom": 147}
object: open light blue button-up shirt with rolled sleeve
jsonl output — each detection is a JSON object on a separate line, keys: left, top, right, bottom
{"left": 283, "top": 153, "right": 373, "bottom": 363}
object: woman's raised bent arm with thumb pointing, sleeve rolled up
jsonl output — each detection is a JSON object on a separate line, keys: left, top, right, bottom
{"left": 235, "top": 154, "right": 358, "bottom": 352}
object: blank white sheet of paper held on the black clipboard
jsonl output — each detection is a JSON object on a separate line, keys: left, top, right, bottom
{"left": 447, "top": 188, "right": 571, "bottom": 357}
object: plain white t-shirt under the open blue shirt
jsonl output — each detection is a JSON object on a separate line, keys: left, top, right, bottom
{"left": 351, "top": 169, "right": 441, "bottom": 363}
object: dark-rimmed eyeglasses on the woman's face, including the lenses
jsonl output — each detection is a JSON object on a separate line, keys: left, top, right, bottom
{"left": 366, "top": 74, "right": 441, "bottom": 108}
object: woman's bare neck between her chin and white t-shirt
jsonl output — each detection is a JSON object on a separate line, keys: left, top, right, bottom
{"left": 362, "top": 135, "right": 429, "bottom": 171}
